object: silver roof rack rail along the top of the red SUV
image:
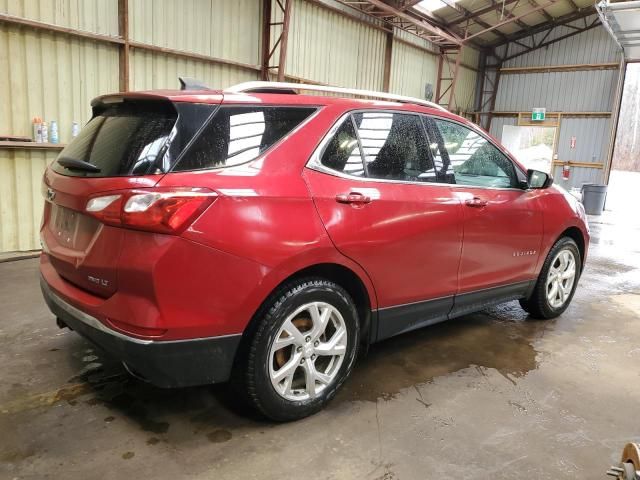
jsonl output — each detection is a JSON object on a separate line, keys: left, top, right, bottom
{"left": 223, "top": 81, "right": 446, "bottom": 111}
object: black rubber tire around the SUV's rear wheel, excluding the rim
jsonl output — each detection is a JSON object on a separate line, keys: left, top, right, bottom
{"left": 236, "top": 277, "right": 360, "bottom": 422}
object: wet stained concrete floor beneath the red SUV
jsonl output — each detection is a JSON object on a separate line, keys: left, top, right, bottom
{"left": 0, "top": 215, "right": 640, "bottom": 480}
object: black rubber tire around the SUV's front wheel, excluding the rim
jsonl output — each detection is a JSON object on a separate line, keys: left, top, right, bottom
{"left": 520, "top": 237, "right": 582, "bottom": 319}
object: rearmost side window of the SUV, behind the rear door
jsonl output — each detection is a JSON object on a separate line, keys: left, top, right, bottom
{"left": 173, "top": 106, "right": 315, "bottom": 171}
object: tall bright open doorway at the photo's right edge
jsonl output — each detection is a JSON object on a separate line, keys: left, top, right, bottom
{"left": 606, "top": 63, "right": 640, "bottom": 221}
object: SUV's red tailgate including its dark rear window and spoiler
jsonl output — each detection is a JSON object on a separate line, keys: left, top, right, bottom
{"left": 41, "top": 95, "right": 217, "bottom": 298}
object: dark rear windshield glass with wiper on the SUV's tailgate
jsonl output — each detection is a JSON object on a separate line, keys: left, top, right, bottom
{"left": 53, "top": 101, "right": 178, "bottom": 177}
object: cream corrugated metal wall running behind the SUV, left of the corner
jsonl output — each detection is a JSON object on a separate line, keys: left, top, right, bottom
{"left": 0, "top": 0, "right": 477, "bottom": 252}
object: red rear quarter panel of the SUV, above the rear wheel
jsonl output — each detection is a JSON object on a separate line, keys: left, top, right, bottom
{"left": 158, "top": 106, "right": 377, "bottom": 325}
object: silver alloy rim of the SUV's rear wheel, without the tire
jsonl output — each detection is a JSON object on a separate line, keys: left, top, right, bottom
{"left": 269, "top": 302, "right": 348, "bottom": 401}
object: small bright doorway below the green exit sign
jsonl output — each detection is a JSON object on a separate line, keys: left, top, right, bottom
{"left": 502, "top": 125, "right": 556, "bottom": 173}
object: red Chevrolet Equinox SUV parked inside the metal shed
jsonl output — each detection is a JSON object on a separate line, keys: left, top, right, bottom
{"left": 40, "top": 82, "right": 589, "bottom": 420}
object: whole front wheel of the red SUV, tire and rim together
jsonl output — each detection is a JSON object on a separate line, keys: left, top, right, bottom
{"left": 520, "top": 237, "right": 582, "bottom": 319}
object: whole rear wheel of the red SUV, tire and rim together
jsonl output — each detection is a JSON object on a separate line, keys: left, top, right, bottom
{"left": 243, "top": 278, "right": 360, "bottom": 421}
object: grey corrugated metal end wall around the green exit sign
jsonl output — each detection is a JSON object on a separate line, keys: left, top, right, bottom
{"left": 491, "top": 18, "right": 620, "bottom": 188}
